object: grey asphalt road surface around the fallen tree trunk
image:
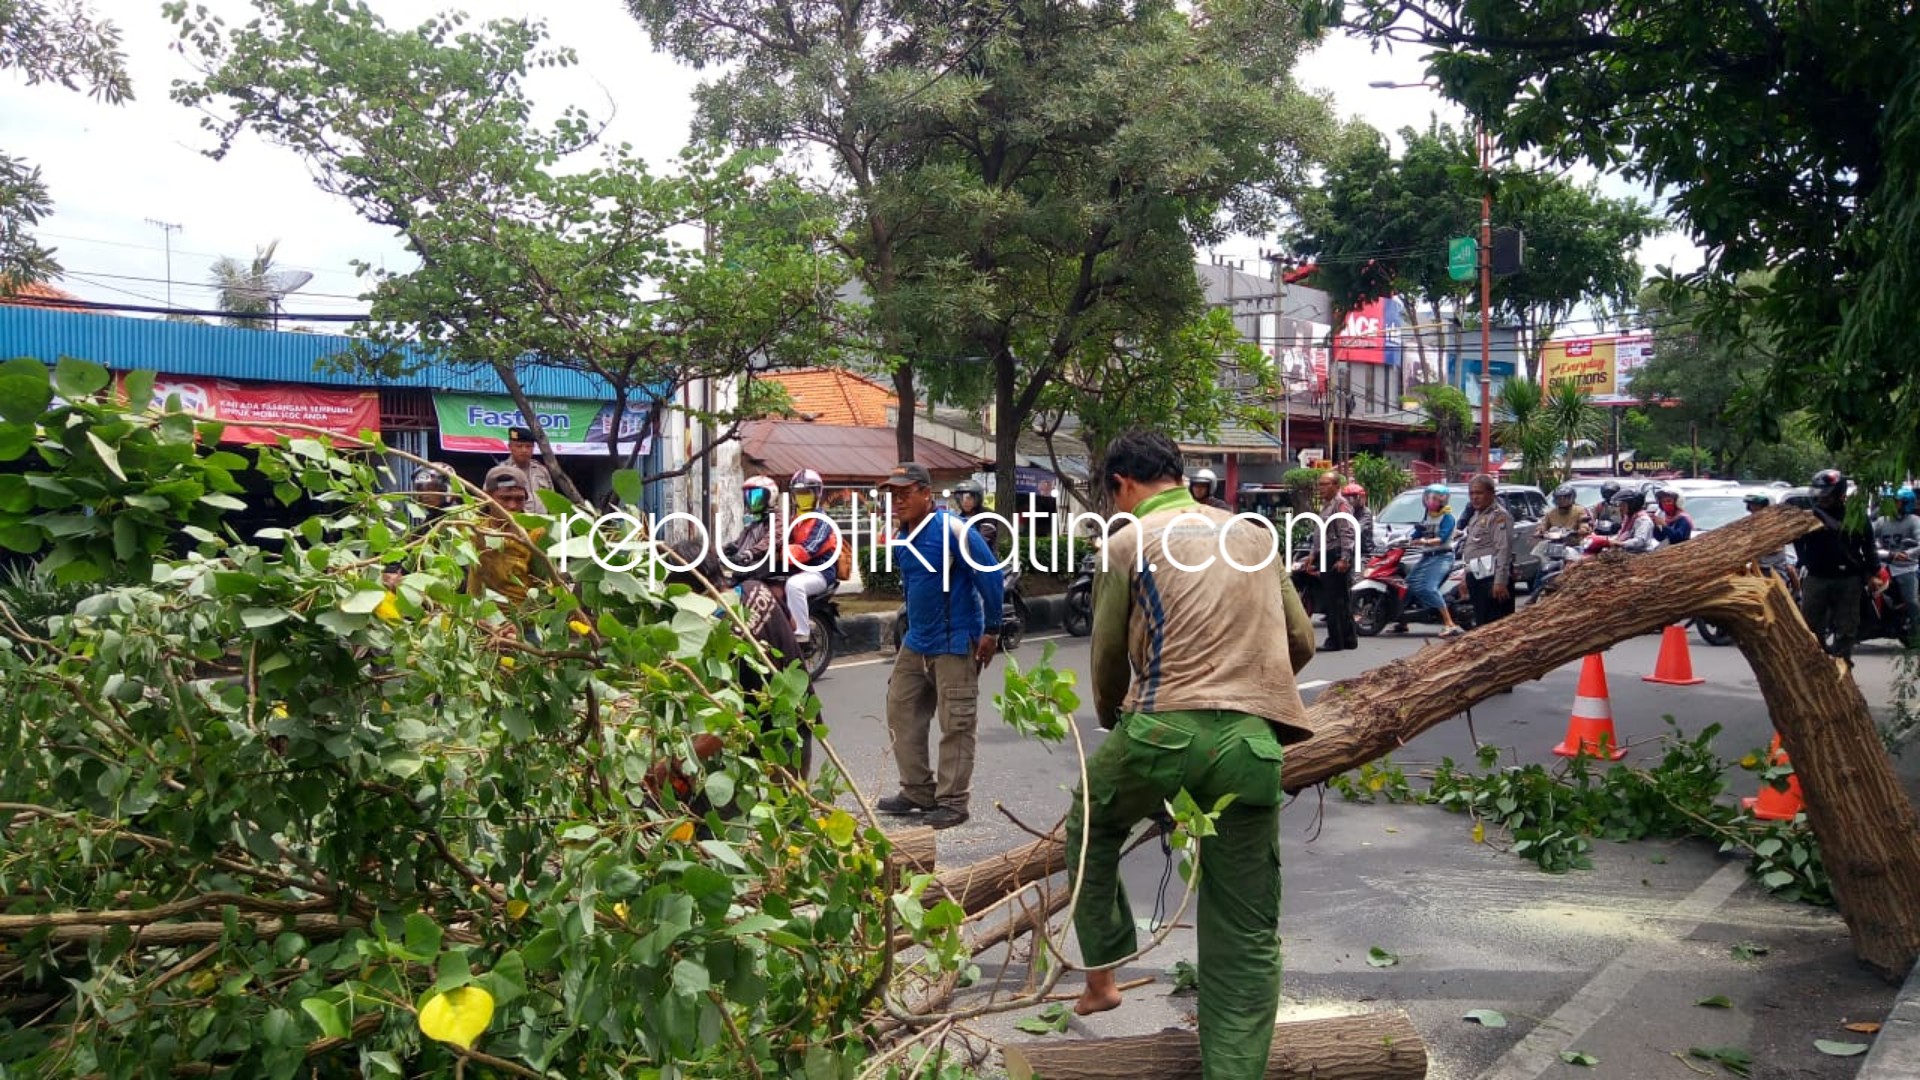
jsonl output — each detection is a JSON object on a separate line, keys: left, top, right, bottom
{"left": 820, "top": 626, "right": 1920, "bottom": 1080}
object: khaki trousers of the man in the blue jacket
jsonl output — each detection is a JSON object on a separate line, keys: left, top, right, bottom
{"left": 887, "top": 646, "right": 979, "bottom": 811}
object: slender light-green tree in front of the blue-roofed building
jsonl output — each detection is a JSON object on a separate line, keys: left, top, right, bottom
{"left": 169, "top": 0, "right": 845, "bottom": 500}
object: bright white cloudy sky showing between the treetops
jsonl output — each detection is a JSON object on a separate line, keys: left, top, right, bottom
{"left": 0, "top": 0, "right": 1699, "bottom": 328}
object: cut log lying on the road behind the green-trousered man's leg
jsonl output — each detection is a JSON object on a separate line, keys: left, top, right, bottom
{"left": 1000, "top": 1013, "right": 1427, "bottom": 1080}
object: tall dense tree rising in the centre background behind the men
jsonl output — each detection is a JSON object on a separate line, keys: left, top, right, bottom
{"left": 634, "top": 0, "right": 1325, "bottom": 496}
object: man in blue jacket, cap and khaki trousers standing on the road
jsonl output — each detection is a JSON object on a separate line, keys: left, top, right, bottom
{"left": 874, "top": 461, "right": 1004, "bottom": 828}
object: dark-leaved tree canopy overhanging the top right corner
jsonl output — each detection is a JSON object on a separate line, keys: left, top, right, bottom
{"left": 1323, "top": 0, "right": 1920, "bottom": 473}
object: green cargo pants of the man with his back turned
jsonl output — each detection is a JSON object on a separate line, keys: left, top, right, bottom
{"left": 1068, "top": 711, "right": 1281, "bottom": 1080}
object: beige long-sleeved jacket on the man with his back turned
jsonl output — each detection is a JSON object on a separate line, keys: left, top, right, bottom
{"left": 1092, "top": 488, "right": 1313, "bottom": 744}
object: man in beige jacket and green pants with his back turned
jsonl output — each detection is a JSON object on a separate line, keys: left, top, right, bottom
{"left": 1068, "top": 432, "right": 1313, "bottom": 1080}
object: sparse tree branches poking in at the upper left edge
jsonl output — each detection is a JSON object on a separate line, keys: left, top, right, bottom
{"left": 0, "top": 0, "right": 132, "bottom": 294}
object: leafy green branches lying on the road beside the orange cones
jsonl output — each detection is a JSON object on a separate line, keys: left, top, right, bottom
{"left": 1329, "top": 717, "right": 1834, "bottom": 905}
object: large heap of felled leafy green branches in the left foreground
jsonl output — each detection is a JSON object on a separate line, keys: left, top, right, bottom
{"left": 0, "top": 361, "right": 983, "bottom": 1078}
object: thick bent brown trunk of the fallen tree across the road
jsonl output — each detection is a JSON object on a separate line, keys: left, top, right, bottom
{"left": 941, "top": 507, "right": 1920, "bottom": 978}
